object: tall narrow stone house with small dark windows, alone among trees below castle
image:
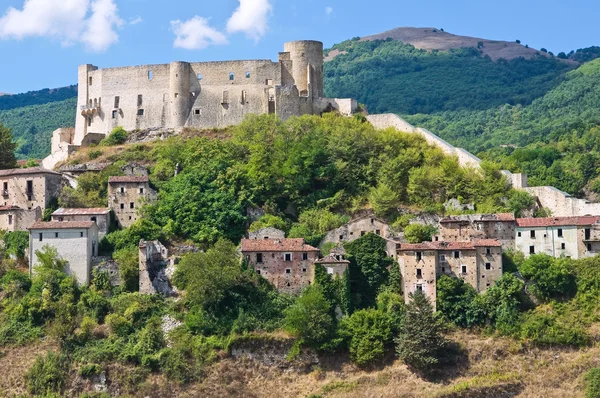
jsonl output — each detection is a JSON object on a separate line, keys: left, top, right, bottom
{"left": 108, "top": 176, "right": 156, "bottom": 228}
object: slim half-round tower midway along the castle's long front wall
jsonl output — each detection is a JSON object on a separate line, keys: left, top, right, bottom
{"left": 169, "top": 62, "right": 191, "bottom": 128}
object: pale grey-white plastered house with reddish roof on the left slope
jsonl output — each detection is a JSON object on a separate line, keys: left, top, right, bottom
{"left": 29, "top": 221, "right": 98, "bottom": 285}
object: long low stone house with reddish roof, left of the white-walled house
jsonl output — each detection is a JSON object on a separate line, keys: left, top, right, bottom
{"left": 434, "top": 213, "right": 515, "bottom": 249}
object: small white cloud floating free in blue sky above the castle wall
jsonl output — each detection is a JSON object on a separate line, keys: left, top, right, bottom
{"left": 171, "top": 15, "right": 227, "bottom": 50}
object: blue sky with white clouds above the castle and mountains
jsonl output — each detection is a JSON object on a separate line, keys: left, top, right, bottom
{"left": 0, "top": 0, "right": 600, "bottom": 94}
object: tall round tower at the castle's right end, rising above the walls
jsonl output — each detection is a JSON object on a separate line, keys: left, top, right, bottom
{"left": 283, "top": 40, "right": 323, "bottom": 98}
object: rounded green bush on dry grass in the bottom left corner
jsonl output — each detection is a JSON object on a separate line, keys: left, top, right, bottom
{"left": 25, "top": 352, "right": 70, "bottom": 395}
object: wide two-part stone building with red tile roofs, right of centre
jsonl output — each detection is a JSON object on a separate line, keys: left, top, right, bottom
{"left": 398, "top": 239, "right": 502, "bottom": 307}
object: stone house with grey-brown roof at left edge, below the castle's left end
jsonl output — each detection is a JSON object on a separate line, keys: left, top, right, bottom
{"left": 0, "top": 167, "right": 62, "bottom": 213}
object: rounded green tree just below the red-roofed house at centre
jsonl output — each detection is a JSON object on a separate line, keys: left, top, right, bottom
{"left": 283, "top": 286, "right": 334, "bottom": 347}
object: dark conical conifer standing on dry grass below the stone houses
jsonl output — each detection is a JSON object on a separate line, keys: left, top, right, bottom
{"left": 396, "top": 291, "right": 448, "bottom": 373}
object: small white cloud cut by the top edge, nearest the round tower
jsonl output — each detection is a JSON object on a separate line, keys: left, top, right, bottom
{"left": 227, "top": 0, "right": 273, "bottom": 41}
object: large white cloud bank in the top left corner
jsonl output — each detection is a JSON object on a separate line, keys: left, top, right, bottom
{"left": 0, "top": 0, "right": 123, "bottom": 51}
